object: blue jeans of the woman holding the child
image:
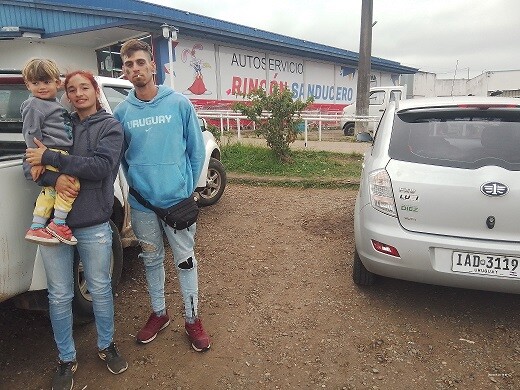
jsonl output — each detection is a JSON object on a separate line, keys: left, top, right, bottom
{"left": 40, "top": 222, "right": 114, "bottom": 362}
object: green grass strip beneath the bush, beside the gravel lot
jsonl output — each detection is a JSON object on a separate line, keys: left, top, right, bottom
{"left": 221, "top": 142, "right": 363, "bottom": 188}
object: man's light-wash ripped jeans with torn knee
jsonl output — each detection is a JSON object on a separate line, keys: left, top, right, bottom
{"left": 131, "top": 209, "right": 199, "bottom": 319}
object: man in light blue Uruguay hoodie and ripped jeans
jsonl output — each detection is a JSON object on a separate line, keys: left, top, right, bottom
{"left": 114, "top": 39, "right": 210, "bottom": 351}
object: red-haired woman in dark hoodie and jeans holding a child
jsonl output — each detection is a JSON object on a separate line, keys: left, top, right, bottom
{"left": 26, "top": 71, "right": 128, "bottom": 390}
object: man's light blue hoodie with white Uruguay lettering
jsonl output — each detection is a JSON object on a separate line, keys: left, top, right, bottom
{"left": 114, "top": 85, "right": 205, "bottom": 211}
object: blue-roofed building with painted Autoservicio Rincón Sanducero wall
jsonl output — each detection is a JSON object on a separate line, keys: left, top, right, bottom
{"left": 0, "top": 0, "right": 417, "bottom": 110}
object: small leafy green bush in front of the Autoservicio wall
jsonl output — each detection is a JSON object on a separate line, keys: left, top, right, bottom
{"left": 233, "top": 84, "right": 314, "bottom": 162}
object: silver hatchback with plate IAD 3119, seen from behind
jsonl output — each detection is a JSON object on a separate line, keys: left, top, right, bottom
{"left": 353, "top": 97, "right": 520, "bottom": 294}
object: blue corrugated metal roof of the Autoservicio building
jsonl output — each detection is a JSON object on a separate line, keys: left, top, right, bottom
{"left": 0, "top": 0, "right": 417, "bottom": 74}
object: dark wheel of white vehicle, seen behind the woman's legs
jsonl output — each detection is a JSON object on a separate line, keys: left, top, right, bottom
{"left": 72, "top": 221, "right": 123, "bottom": 325}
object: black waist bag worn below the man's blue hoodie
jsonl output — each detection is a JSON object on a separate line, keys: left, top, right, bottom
{"left": 130, "top": 187, "right": 199, "bottom": 230}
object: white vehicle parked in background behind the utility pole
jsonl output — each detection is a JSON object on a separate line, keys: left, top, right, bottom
{"left": 340, "top": 85, "right": 406, "bottom": 135}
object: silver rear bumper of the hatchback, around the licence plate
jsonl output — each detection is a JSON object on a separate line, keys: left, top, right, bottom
{"left": 354, "top": 201, "right": 520, "bottom": 294}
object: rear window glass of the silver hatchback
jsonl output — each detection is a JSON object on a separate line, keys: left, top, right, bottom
{"left": 389, "top": 107, "right": 520, "bottom": 171}
